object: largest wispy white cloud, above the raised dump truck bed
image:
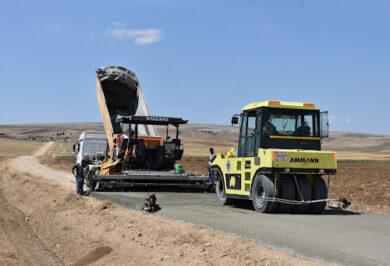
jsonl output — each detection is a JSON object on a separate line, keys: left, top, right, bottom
{"left": 109, "top": 27, "right": 163, "bottom": 45}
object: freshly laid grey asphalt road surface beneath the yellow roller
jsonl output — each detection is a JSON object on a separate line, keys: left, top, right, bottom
{"left": 93, "top": 191, "right": 390, "bottom": 265}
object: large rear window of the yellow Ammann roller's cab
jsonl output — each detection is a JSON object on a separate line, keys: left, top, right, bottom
{"left": 262, "top": 109, "right": 320, "bottom": 137}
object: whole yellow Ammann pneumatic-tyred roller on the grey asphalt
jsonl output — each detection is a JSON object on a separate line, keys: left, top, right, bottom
{"left": 212, "top": 101, "right": 337, "bottom": 213}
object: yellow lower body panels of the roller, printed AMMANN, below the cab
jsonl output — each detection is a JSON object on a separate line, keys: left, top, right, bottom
{"left": 212, "top": 149, "right": 337, "bottom": 196}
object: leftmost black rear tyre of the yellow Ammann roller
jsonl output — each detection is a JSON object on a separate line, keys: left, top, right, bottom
{"left": 251, "top": 175, "right": 276, "bottom": 213}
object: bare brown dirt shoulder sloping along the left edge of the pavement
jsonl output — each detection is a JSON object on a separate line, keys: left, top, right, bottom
{"left": 0, "top": 150, "right": 313, "bottom": 265}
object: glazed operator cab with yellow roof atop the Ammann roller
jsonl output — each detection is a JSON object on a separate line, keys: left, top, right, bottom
{"left": 232, "top": 101, "right": 329, "bottom": 156}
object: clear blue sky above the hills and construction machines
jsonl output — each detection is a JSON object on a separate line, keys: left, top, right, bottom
{"left": 0, "top": 0, "right": 390, "bottom": 134}
